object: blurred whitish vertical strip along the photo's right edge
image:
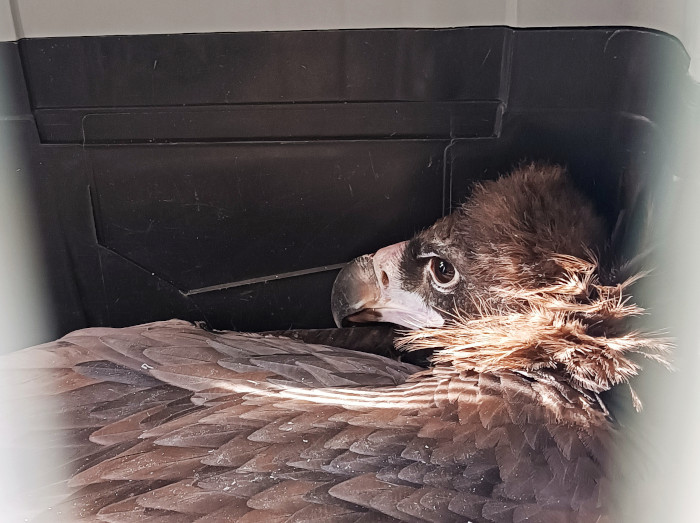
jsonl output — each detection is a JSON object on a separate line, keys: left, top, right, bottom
{"left": 612, "top": 12, "right": 700, "bottom": 523}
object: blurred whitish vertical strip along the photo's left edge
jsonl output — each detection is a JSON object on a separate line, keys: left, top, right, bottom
{"left": 0, "top": 69, "right": 68, "bottom": 521}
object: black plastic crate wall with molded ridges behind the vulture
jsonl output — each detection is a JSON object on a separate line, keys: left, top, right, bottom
{"left": 0, "top": 27, "right": 694, "bottom": 335}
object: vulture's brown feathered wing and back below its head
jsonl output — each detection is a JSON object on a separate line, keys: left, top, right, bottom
{"left": 2, "top": 321, "right": 611, "bottom": 523}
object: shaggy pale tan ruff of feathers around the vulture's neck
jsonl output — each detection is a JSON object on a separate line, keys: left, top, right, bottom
{"left": 397, "top": 255, "right": 671, "bottom": 410}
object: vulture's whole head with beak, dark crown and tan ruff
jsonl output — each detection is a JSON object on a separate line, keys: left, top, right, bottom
{"left": 332, "top": 164, "right": 668, "bottom": 406}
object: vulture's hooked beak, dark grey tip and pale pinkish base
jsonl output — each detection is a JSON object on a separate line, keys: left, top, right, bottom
{"left": 331, "top": 242, "right": 444, "bottom": 329}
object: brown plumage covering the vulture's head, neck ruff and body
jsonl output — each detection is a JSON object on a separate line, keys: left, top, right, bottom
{"left": 4, "top": 166, "right": 668, "bottom": 523}
